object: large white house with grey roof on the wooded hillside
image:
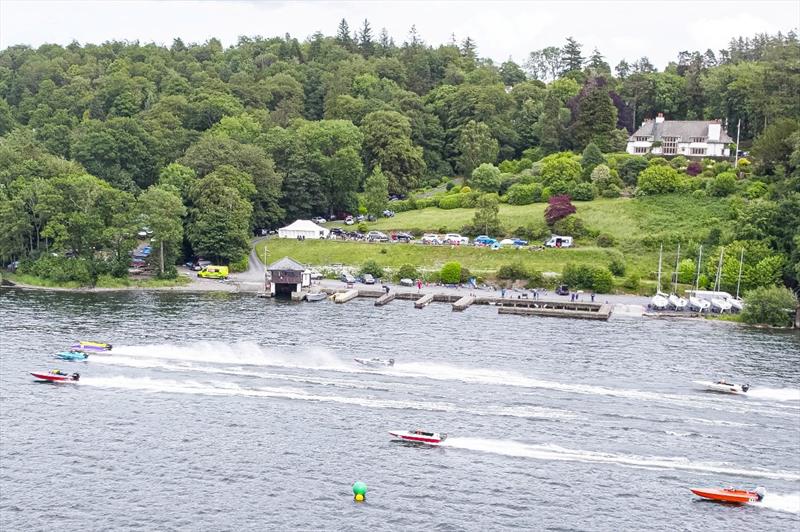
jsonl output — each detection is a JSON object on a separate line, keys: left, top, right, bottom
{"left": 626, "top": 113, "right": 733, "bottom": 157}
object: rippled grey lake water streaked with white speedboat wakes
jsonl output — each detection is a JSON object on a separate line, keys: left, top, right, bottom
{"left": 0, "top": 289, "right": 800, "bottom": 531}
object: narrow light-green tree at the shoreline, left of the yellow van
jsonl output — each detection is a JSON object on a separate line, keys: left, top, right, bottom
{"left": 139, "top": 185, "right": 186, "bottom": 277}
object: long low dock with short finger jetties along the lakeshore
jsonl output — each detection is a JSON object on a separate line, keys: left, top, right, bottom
{"left": 323, "top": 288, "right": 612, "bottom": 320}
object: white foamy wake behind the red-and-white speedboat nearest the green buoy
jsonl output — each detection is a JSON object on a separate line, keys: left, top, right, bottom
{"left": 442, "top": 437, "right": 800, "bottom": 481}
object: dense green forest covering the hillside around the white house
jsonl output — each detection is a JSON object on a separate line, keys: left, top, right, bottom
{"left": 0, "top": 20, "right": 800, "bottom": 285}
